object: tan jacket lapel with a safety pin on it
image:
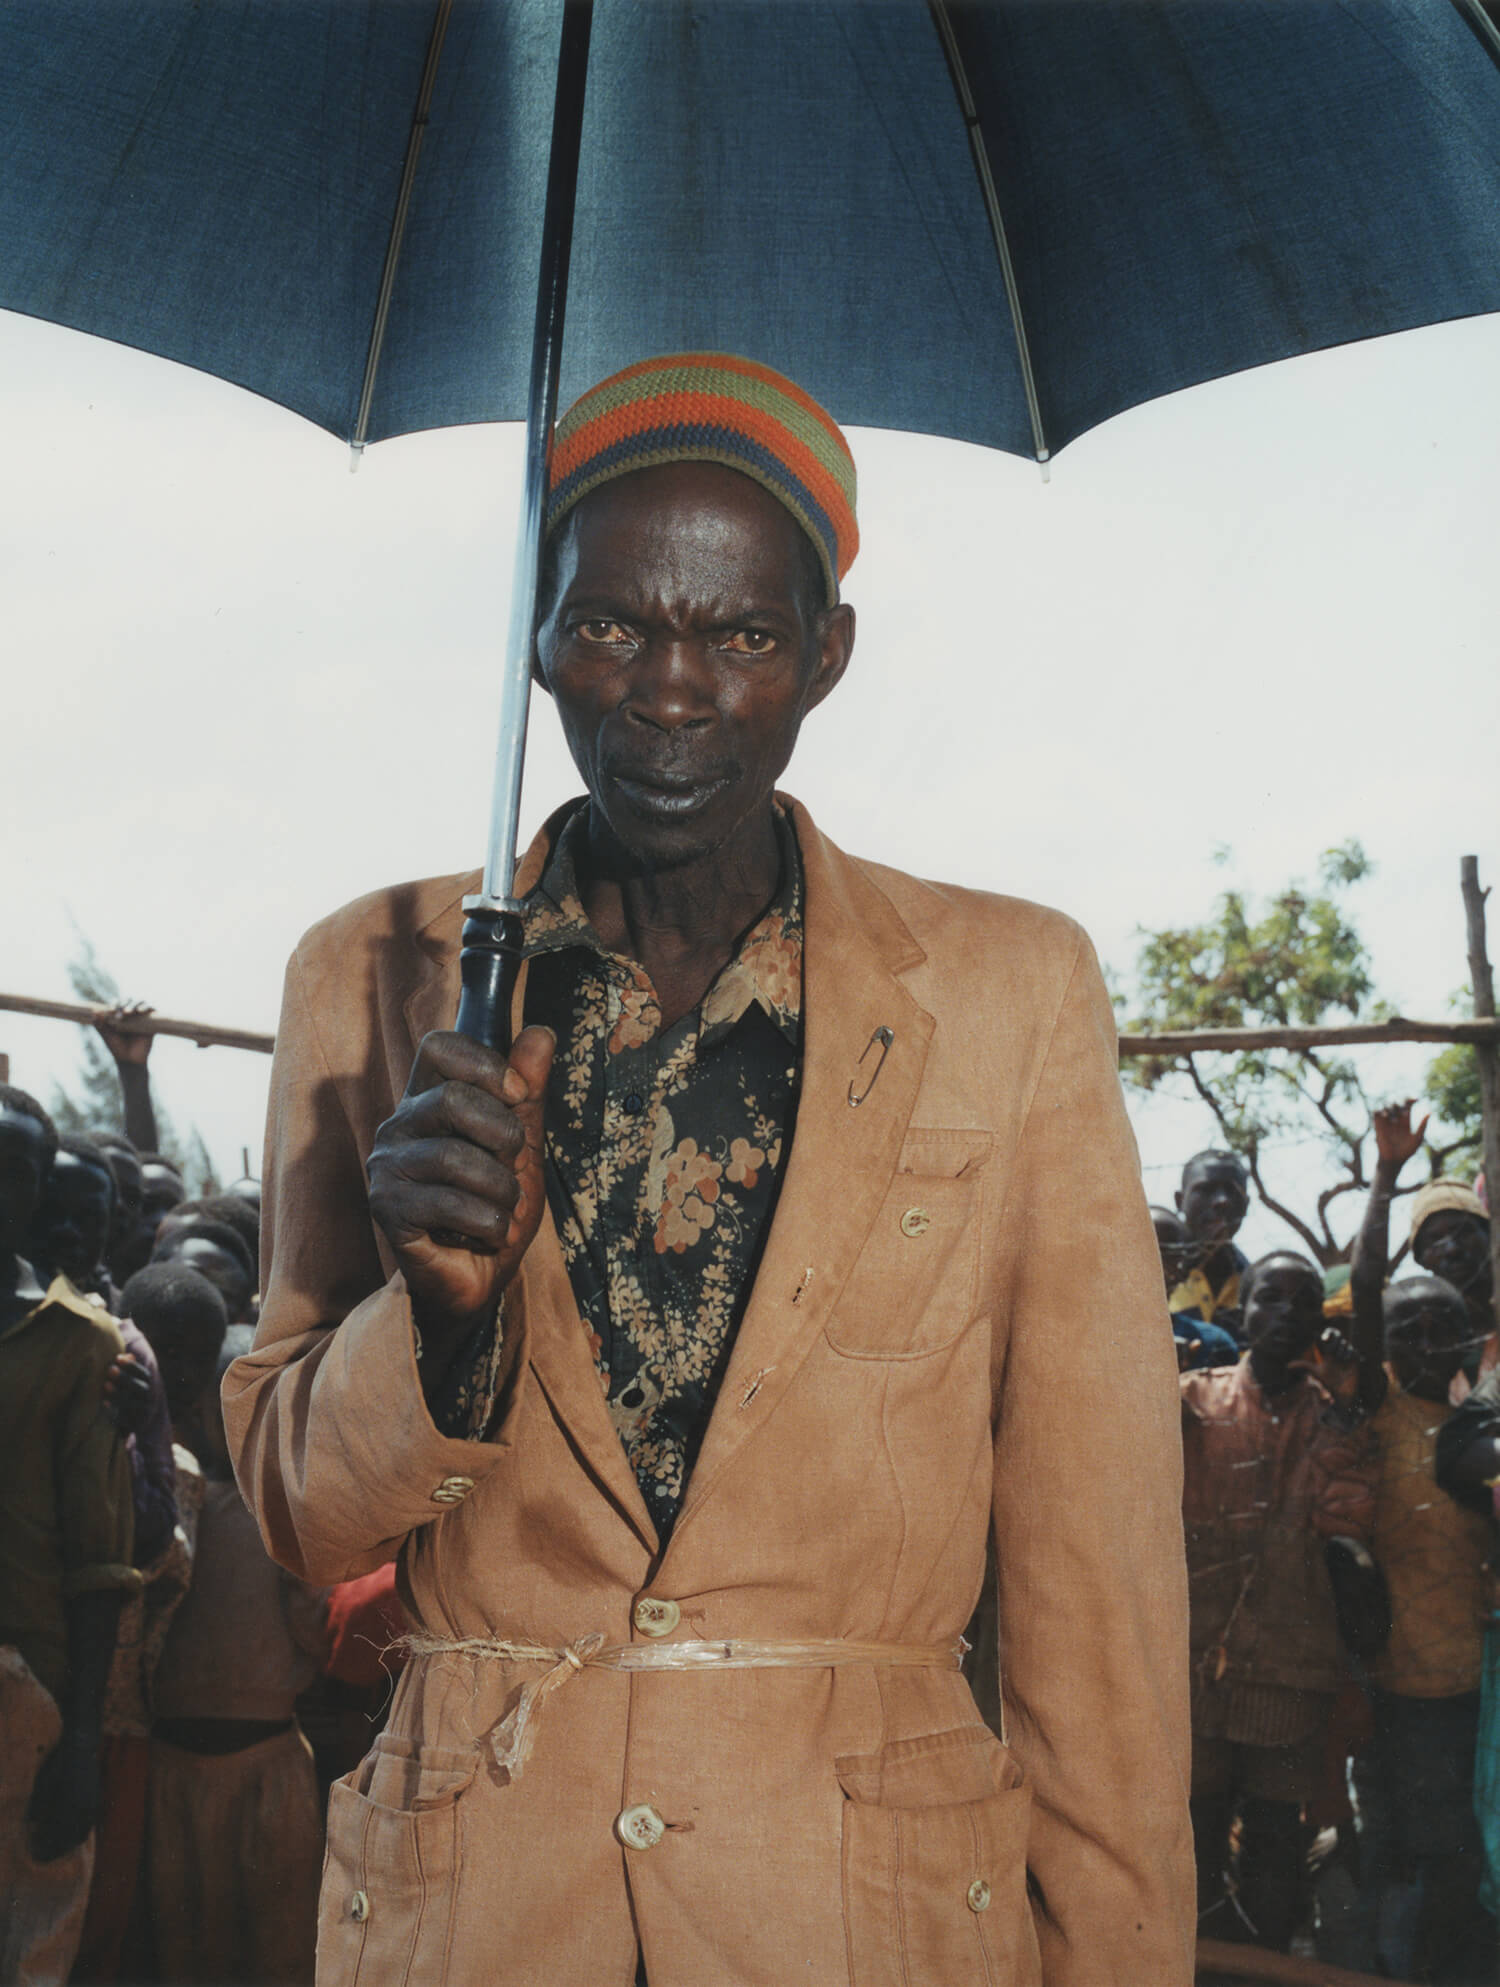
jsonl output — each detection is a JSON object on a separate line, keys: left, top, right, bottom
{"left": 674, "top": 803, "right": 934, "bottom": 1538}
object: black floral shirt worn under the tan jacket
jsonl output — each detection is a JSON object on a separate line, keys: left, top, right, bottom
{"left": 445, "top": 805, "right": 803, "bottom": 1542}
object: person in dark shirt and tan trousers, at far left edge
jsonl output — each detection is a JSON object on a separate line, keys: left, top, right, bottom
{"left": 0, "top": 1085, "right": 141, "bottom": 1987}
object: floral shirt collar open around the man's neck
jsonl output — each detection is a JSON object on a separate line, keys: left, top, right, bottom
{"left": 521, "top": 801, "right": 803, "bottom": 1047}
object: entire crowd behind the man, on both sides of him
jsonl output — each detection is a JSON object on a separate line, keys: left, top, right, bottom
{"left": 0, "top": 1037, "right": 1500, "bottom": 1987}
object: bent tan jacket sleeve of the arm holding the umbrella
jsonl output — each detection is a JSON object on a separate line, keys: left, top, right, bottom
{"left": 225, "top": 952, "right": 526, "bottom": 1586}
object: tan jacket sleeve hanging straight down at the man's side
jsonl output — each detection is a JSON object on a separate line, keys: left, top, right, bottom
{"left": 995, "top": 934, "right": 1196, "bottom": 1987}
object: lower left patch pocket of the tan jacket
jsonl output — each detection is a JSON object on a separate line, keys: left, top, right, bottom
{"left": 318, "top": 1737, "right": 479, "bottom": 1987}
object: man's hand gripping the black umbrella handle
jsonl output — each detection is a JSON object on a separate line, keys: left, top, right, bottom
{"left": 368, "top": 1027, "right": 554, "bottom": 1357}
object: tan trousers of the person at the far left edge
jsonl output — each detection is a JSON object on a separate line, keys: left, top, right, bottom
{"left": 0, "top": 1647, "right": 93, "bottom": 1987}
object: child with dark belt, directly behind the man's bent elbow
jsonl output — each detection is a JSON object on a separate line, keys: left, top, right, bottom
{"left": 129, "top": 1264, "right": 326, "bottom": 1987}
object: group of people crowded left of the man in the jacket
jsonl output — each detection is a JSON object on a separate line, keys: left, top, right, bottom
{"left": 0, "top": 1085, "right": 401, "bottom": 1987}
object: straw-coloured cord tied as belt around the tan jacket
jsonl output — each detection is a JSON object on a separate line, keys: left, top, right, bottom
{"left": 395, "top": 1629, "right": 968, "bottom": 1780}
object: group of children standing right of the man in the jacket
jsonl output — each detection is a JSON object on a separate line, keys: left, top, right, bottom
{"left": 1176, "top": 1105, "right": 1500, "bottom": 1987}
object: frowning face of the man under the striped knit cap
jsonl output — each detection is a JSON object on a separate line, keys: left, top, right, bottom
{"left": 536, "top": 463, "right": 854, "bottom": 870}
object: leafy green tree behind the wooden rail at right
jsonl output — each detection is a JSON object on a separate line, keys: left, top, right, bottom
{"left": 1125, "top": 841, "right": 1478, "bottom": 1268}
